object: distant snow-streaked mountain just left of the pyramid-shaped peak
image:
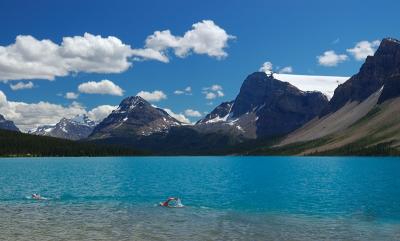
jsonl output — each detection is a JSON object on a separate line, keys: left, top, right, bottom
{"left": 29, "top": 115, "right": 96, "bottom": 140}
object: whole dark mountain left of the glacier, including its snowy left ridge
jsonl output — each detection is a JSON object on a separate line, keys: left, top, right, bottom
{"left": 196, "top": 72, "right": 328, "bottom": 138}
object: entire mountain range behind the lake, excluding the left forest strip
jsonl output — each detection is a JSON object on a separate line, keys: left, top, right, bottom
{"left": 0, "top": 38, "right": 400, "bottom": 155}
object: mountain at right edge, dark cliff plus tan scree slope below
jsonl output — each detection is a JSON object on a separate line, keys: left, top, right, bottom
{"left": 280, "top": 38, "right": 400, "bottom": 154}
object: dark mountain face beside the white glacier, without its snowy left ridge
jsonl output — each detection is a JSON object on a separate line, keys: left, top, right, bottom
{"left": 232, "top": 72, "right": 328, "bottom": 137}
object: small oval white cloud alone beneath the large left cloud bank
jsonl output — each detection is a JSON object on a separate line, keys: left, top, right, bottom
{"left": 78, "top": 80, "right": 124, "bottom": 96}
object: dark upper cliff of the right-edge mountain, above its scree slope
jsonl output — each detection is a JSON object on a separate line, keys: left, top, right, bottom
{"left": 321, "top": 38, "right": 400, "bottom": 116}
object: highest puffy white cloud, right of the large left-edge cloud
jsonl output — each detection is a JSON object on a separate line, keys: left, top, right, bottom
{"left": 146, "top": 20, "right": 236, "bottom": 58}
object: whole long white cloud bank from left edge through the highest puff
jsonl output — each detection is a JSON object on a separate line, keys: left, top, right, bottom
{"left": 0, "top": 20, "right": 235, "bottom": 81}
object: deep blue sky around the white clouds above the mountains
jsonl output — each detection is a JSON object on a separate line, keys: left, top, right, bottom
{"left": 0, "top": 0, "right": 400, "bottom": 131}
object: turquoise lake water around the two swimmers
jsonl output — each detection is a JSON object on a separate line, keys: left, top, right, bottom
{"left": 0, "top": 157, "right": 400, "bottom": 240}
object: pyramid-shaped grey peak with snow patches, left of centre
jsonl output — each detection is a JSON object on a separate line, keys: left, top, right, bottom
{"left": 90, "top": 96, "right": 181, "bottom": 139}
